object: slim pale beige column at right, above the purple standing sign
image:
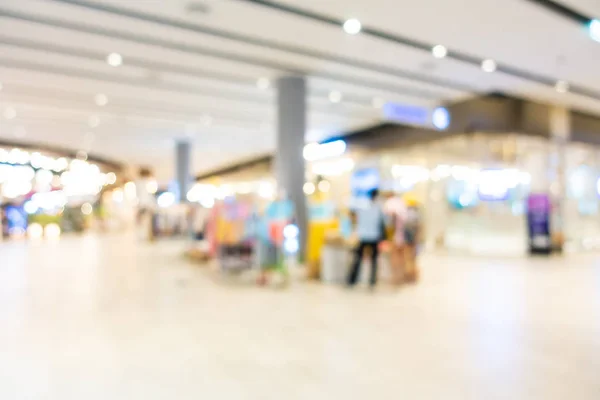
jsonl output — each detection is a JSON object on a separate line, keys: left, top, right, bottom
{"left": 549, "top": 106, "right": 571, "bottom": 244}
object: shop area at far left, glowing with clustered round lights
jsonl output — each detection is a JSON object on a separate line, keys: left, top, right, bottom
{"left": 0, "top": 143, "right": 132, "bottom": 239}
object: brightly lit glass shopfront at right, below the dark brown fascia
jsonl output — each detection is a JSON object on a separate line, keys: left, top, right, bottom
{"left": 308, "top": 133, "right": 600, "bottom": 256}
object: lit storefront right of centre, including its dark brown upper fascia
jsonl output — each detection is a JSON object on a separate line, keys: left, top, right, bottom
{"left": 190, "top": 96, "right": 600, "bottom": 256}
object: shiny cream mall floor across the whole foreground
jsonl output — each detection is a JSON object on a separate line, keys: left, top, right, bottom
{"left": 0, "top": 236, "right": 600, "bottom": 400}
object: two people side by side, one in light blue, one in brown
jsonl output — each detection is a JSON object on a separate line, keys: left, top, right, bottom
{"left": 348, "top": 189, "right": 422, "bottom": 287}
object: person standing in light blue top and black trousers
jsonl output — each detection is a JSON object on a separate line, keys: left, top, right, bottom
{"left": 348, "top": 189, "right": 385, "bottom": 287}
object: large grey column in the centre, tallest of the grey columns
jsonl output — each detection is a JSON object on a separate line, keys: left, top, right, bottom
{"left": 274, "top": 76, "right": 307, "bottom": 257}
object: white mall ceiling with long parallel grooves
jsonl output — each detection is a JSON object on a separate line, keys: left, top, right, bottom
{"left": 0, "top": 0, "right": 600, "bottom": 176}
